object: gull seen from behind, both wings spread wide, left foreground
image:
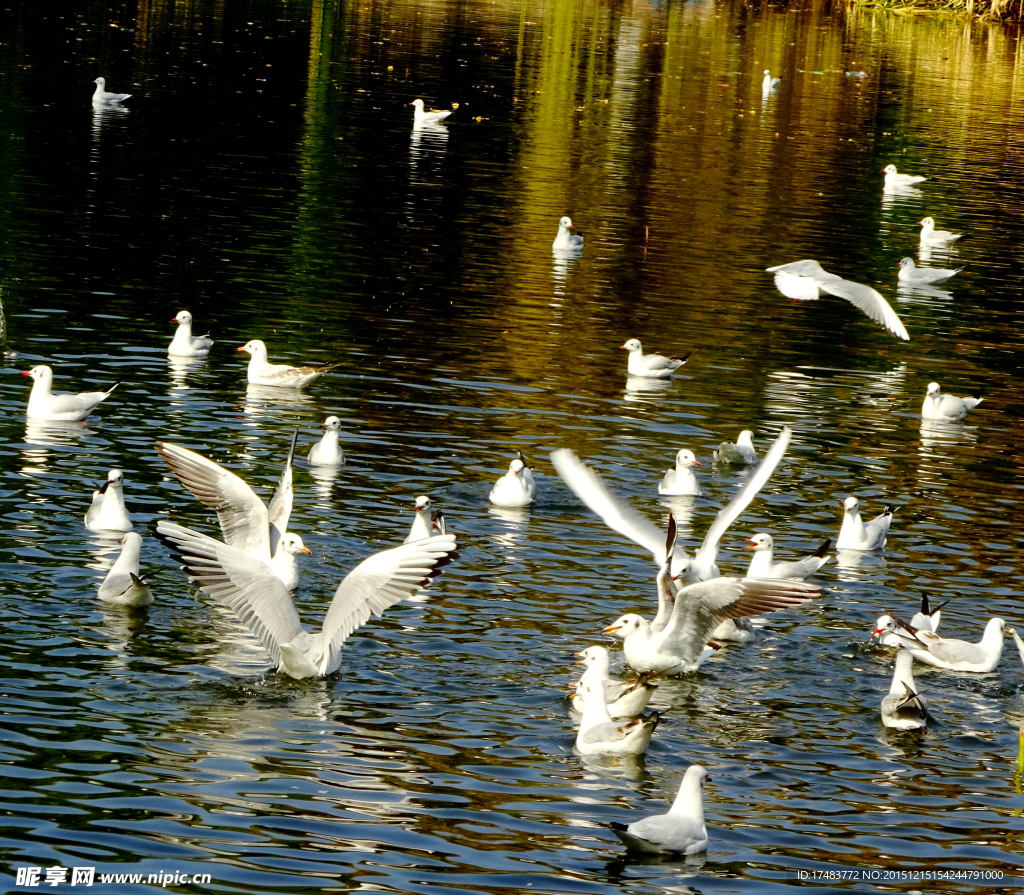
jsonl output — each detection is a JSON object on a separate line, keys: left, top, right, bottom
{"left": 157, "top": 519, "right": 456, "bottom": 680}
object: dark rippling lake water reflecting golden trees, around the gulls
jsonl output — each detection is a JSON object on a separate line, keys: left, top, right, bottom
{"left": 0, "top": 0, "right": 1024, "bottom": 895}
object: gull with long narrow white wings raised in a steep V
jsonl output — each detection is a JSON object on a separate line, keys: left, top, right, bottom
{"left": 551, "top": 426, "right": 793, "bottom": 584}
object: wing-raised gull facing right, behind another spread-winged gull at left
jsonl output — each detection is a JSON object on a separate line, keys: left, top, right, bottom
{"left": 157, "top": 432, "right": 309, "bottom": 590}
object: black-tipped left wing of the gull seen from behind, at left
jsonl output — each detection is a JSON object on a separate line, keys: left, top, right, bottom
{"left": 157, "top": 519, "right": 305, "bottom": 666}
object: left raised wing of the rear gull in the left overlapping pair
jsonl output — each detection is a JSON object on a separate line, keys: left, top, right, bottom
{"left": 157, "top": 441, "right": 270, "bottom": 561}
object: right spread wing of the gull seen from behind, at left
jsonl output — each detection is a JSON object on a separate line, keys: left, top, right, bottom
{"left": 319, "top": 535, "right": 456, "bottom": 675}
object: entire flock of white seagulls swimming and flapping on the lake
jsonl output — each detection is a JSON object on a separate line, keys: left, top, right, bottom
{"left": 46, "top": 78, "right": 991, "bottom": 855}
